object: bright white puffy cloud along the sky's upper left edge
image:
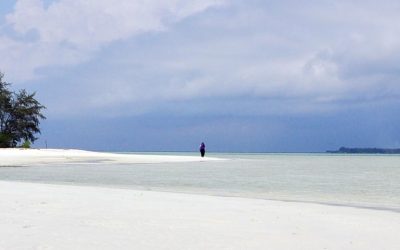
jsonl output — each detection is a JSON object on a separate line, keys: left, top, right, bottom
{"left": 7, "top": 0, "right": 227, "bottom": 49}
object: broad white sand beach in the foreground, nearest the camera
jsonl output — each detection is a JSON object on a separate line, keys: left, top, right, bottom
{"left": 0, "top": 182, "right": 400, "bottom": 250}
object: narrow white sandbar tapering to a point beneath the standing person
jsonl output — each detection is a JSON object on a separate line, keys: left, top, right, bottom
{"left": 0, "top": 149, "right": 221, "bottom": 166}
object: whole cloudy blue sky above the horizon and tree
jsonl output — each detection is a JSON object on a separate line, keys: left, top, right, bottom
{"left": 0, "top": 0, "right": 400, "bottom": 152}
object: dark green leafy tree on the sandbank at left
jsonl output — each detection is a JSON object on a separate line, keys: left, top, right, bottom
{"left": 0, "top": 72, "right": 46, "bottom": 148}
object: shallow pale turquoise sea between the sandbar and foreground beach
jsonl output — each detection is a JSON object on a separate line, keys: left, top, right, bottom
{"left": 0, "top": 153, "right": 400, "bottom": 212}
